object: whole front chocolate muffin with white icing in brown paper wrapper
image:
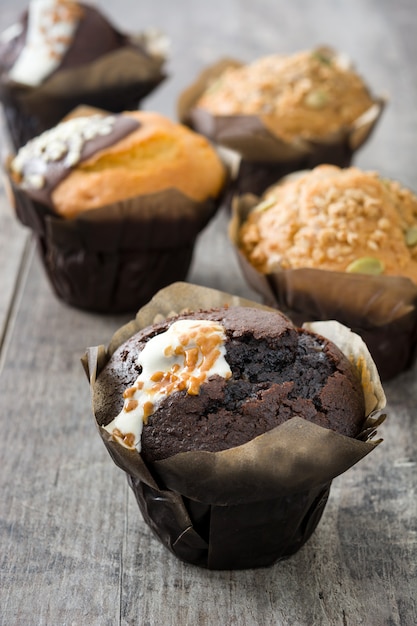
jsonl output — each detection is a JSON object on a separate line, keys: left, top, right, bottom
{"left": 83, "top": 283, "right": 384, "bottom": 569}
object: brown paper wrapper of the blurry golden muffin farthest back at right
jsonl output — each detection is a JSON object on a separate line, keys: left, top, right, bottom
{"left": 177, "top": 58, "right": 385, "bottom": 197}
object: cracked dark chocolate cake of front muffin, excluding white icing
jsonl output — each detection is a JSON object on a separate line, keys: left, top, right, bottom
{"left": 98, "top": 307, "right": 365, "bottom": 462}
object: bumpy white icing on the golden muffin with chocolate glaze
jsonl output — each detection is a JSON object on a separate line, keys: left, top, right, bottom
{"left": 10, "top": 114, "right": 116, "bottom": 189}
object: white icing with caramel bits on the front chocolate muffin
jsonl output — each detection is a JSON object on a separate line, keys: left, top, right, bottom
{"left": 104, "top": 320, "right": 232, "bottom": 451}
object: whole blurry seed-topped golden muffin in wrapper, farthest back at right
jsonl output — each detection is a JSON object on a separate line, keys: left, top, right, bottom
{"left": 179, "top": 47, "right": 384, "bottom": 199}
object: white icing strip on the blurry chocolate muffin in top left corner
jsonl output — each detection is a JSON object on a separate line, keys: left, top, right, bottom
{"left": 9, "top": 0, "right": 79, "bottom": 87}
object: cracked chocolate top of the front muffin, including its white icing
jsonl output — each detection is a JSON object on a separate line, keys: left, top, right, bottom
{"left": 95, "top": 307, "right": 365, "bottom": 462}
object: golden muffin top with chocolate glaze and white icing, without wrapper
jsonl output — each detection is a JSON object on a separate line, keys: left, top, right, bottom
{"left": 10, "top": 111, "right": 225, "bottom": 218}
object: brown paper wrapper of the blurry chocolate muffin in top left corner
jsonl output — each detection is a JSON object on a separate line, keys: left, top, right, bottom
{"left": 0, "top": 42, "right": 165, "bottom": 150}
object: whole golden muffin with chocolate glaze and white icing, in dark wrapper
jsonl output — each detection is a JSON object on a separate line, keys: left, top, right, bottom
{"left": 8, "top": 109, "right": 227, "bottom": 312}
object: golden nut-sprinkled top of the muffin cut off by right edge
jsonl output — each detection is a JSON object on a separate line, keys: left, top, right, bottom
{"left": 239, "top": 165, "right": 417, "bottom": 283}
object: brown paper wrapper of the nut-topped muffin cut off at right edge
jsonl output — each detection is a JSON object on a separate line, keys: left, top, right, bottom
{"left": 229, "top": 194, "right": 417, "bottom": 381}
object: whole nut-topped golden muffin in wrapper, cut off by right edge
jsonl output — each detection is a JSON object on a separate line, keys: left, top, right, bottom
{"left": 231, "top": 165, "right": 417, "bottom": 378}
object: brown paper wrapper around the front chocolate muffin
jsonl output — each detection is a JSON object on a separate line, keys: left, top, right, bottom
{"left": 82, "top": 283, "right": 385, "bottom": 569}
